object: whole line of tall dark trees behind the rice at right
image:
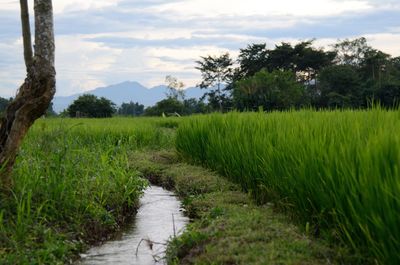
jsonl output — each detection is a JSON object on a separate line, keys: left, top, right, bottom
{"left": 196, "top": 38, "right": 400, "bottom": 111}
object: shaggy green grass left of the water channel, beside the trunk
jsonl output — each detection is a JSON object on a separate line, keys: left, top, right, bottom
{"left": 0, "top": 118, "right": 174, "bottom": 264}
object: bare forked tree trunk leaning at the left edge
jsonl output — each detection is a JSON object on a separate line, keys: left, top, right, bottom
{"left": 0, "top": 0, "right": 56, "bottom": 191}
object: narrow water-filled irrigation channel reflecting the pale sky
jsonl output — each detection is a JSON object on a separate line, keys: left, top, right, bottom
{"left": 77, "top": 186, "right": 189, "bottom": 265}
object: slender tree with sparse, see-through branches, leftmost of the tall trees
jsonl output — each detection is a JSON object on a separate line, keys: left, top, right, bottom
{"left": 196, "top": 53, "right": 233, "bottom": 111}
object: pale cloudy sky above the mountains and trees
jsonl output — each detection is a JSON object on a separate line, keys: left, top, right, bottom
{"left": 0, "top": 0, "right": 400, "bottom": 97}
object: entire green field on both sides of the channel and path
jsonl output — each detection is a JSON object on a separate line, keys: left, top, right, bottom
{"left": 0, "top": 109, "right": 400, "bottom": 264}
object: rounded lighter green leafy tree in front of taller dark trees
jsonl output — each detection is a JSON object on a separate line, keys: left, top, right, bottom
{"left": 233, "top": 70, "right": 304, "bottom": 111}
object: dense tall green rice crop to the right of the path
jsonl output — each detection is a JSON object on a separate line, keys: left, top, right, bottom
{"left": 176, "top": 109, "right": 400, "bottom": 264}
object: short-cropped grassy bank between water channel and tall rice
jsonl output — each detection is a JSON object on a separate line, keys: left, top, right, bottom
{"left": 130, "top": 151, "right": 351, "bottom": 264}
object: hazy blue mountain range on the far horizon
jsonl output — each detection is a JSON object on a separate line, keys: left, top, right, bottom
{"left": 53, "top": 81, "right": 205, "bottom": 112}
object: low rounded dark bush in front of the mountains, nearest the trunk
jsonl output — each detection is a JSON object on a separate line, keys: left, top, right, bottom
{"left": 67, "top": 94, "right": 115, "bottom": 118}
